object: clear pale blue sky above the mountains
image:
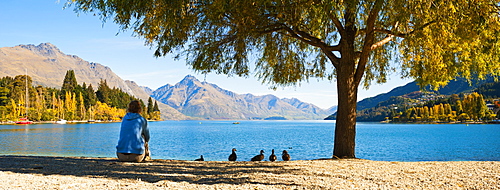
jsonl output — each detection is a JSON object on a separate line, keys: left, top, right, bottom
{"left": 0, "top": 0, "right": 409, "bottom": 109}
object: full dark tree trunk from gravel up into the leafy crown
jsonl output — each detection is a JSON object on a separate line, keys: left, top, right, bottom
{"left": 331, "top": 7, "right": 364, "bottom": 158}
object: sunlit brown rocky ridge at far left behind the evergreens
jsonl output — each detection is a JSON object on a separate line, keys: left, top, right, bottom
{"left": 0, "top": 43, "right": 133, "bottom": 94}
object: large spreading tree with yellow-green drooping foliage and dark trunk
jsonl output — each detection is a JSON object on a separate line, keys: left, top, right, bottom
{"left": 69, "top": 0, "right": 500, "bottom": 158}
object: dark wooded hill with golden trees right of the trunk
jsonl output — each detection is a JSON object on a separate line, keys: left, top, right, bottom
{"left": 326, "top": 77, "right": 500, "bottom": 122}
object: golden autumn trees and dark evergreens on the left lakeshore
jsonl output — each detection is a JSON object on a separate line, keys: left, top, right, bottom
{"left": 0, "top": 70, "right": 160, "bottom": 122}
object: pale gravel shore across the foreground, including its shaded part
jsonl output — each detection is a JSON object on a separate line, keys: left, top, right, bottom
{"left": 0, "top": 156, "right": 500, "bottom": 189}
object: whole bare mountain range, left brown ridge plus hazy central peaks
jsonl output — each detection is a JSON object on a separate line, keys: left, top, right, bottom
{"left": 0, "top": 43, "right": 336, "bottom": 120}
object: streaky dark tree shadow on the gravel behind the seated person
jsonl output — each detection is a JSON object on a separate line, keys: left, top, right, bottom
{"left": 0, "top": 156, "right": 302, "bottom": 185}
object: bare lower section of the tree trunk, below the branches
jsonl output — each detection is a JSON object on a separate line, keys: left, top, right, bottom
{"left": 333, "top": 63, "right": 358, "bottom": 158}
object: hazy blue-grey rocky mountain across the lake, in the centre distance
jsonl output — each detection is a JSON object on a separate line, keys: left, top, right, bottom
{"left": 152, "top": 75, "right": 329, "bottom": 119}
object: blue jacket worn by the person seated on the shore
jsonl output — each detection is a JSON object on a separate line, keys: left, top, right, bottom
{"left": 116, "top": 112, "right": 149, "bottom": 154}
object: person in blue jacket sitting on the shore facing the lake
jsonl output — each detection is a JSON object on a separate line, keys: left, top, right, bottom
{"left": 116, "top": 100, "right": 149, "bottom": 162}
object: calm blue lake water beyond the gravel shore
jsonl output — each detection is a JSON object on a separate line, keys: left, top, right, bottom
{"left": 0, "top": 120, "right": 500, "bottom": 161}
